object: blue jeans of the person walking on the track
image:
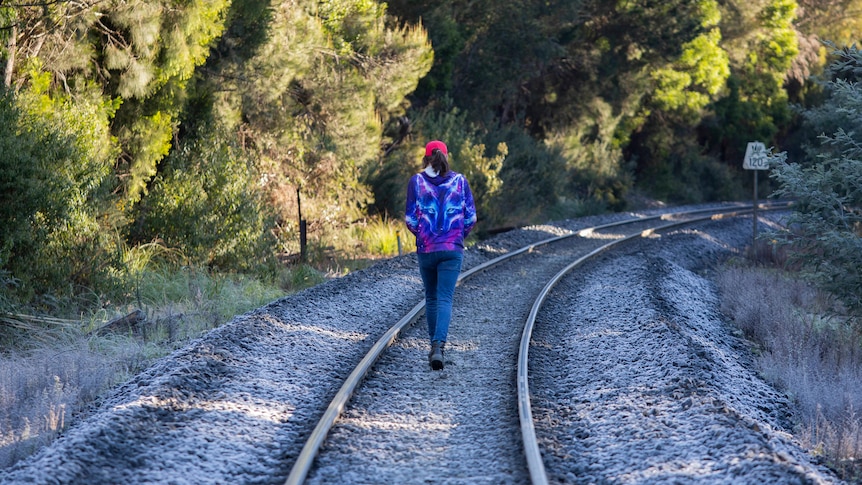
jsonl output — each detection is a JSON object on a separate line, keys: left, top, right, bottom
{"left": 416, "top": 251, "right": 464, "bottom": 342}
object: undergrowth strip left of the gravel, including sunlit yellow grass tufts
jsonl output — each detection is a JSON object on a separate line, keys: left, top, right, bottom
{"left": 0, "top": 219, "right": 416, "bottom": 468}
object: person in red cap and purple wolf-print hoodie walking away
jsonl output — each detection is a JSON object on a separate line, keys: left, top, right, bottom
{"left": 404, "top": 140, "right": 476, "bottom": 370}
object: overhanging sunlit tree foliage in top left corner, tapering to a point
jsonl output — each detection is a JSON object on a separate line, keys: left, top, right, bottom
{"left": 4, "top": 0, "right": 229, "bottom": 207}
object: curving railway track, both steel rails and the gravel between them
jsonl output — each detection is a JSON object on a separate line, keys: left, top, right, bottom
{"left": 286, "top": 200, "right": 832, "bottom": 484}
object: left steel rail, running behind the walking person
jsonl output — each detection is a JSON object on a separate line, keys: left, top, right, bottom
{"left": 285, "top": 204, "right": 788, "bottom": 485}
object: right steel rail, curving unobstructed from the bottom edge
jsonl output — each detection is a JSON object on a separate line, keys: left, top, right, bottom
{"left": 517, "top": 203, "right": 790, "bottom": 485}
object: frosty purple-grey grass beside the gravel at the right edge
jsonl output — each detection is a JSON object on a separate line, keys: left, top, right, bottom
{"left": 718, "top": 267, "right": 862, "bottom": 483}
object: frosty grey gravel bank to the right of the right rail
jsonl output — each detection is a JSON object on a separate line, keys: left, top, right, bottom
{"left": 531, "top": 222, "right": 839, "bottom": 484}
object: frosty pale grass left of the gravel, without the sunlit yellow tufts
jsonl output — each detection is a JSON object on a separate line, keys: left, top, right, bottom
{"left": 0, "top": 260, "right": 324, "bottom": 468}
